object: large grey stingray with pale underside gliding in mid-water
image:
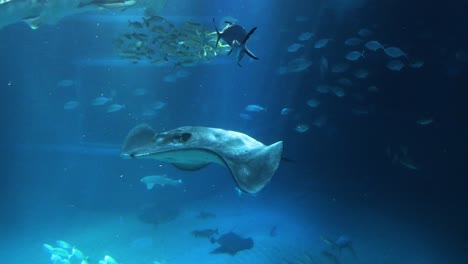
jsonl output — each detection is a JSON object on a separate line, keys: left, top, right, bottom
{"left": 121, "top": 124, "right": 283, "bottom": 193}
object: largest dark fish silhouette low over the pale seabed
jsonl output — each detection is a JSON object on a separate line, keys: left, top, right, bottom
{"left": 210, "top": 232, "right": 253, "bottom": 256}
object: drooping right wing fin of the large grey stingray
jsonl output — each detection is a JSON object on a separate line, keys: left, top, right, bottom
{"left": 224, "top": 141, "right": 283, "bottom": 193}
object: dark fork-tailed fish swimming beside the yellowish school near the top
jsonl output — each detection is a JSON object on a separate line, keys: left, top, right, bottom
{"left": 213, "top": 18, "right": 258, "bottom": 66}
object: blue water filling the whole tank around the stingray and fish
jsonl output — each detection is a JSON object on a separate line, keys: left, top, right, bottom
{"left": 0, "top": 0, "right": 468, "bottom": 264}
